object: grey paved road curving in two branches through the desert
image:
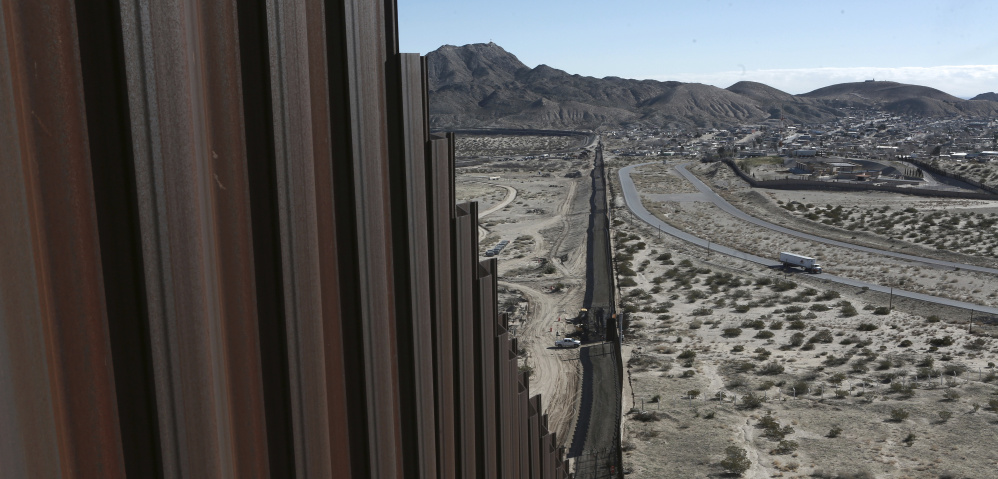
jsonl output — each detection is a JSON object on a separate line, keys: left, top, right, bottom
{"left": 617, "top": 162, "right": 998, "bottom": 314}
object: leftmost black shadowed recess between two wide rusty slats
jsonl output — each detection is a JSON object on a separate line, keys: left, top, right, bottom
{"left": 76, "top": 2, "right": 161, "bottom": 477}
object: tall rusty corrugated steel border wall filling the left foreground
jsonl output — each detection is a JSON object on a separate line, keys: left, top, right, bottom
{"left": 0, "top": 0, "right": 580, "bottom": 478}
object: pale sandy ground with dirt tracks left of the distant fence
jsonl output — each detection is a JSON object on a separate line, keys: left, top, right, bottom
{"left": 456, "top": 137, "right": 591, "bottom": 447}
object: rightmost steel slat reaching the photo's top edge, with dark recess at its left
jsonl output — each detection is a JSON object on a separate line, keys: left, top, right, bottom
{"left": 326, "top": 0, "right": 403, "bottom": 477}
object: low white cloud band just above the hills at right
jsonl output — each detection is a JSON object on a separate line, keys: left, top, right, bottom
{"left": 655, "top": 65, "right": 998, "bottom": 98}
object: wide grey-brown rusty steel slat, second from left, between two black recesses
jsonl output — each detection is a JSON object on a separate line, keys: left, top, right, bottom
{"left": 121, "top": 1, "right": 280, "bottom": 477}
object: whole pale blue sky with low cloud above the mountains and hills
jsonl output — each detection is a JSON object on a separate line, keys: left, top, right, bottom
{"left": 397, "top": 0, "right": 998, "bottom": 97}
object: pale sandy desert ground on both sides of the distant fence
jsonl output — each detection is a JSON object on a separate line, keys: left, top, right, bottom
{"left": 458, "top": 136, "right": 998, "bottom": 478}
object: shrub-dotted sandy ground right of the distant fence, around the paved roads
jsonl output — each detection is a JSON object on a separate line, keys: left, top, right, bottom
{"left": 610, "top": 153, "right": 998, "bottom": 478}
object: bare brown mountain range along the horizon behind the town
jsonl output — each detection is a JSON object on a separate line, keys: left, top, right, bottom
{"left": 426, "top": 43, "right": 998, "bottom": 129}
